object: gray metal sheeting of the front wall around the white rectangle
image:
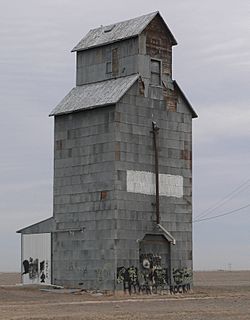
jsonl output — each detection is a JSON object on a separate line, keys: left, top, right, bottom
{"left": 116, "top": 84, "right": 192, "bottom": 269}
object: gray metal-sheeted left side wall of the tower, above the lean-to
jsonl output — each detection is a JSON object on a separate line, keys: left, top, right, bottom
{"left": 52, "top": 106, "right": 116, "bottom": 290}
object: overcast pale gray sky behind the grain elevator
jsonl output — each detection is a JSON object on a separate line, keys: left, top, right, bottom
{"left": 0, "top": 0, "right": 250, "bottom": 271}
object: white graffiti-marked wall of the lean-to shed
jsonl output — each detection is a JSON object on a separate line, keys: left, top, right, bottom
{"left": 22, "top": 233, "right": 51, "bottom": 284}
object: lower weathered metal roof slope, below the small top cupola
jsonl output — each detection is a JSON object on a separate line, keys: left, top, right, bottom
{"left": 50, "top": 74, "right": 139, "bottom": 116}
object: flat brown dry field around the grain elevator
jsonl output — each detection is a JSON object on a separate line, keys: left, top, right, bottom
{"left": 0, "top": 271, "right": 250, "bottom": 320}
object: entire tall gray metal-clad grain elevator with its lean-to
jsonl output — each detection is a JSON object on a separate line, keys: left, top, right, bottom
{"left": 18, "top": 12, "right": 197, "bottom": 293}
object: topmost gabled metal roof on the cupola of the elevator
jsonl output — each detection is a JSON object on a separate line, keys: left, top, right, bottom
{"left": 72, "top": 11, "right": 177, "bottom": 52}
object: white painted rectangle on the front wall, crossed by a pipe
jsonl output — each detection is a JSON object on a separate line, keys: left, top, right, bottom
{"left": 127, "top": 170, "right": 183, "bottom": 198}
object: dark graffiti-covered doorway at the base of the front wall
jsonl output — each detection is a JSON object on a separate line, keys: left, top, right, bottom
{"left": 139, "top": 234, "right": 170, "bottom": 292}
